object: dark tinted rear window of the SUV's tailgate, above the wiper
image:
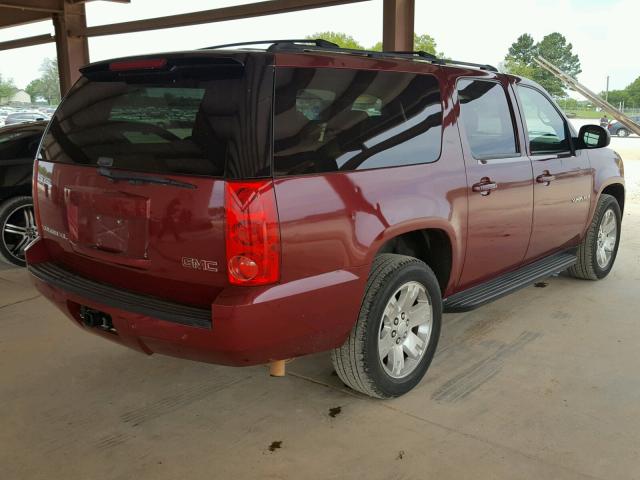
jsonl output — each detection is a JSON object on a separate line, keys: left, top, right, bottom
{"left": 43, "top": 55, "right": 273, "bottom": 178}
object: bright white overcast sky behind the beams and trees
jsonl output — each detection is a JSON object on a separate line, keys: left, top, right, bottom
{"left": 0, "top": 0, "right": 640, "bottom": 96}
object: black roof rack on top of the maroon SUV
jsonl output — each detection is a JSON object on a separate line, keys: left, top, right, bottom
{"left": 204, "top": 38, "right": 498, "bottom": 73}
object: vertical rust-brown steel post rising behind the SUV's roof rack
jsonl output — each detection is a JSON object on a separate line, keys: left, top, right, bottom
{"left": 382, "top": 0, "right": 415, "bottom": 51}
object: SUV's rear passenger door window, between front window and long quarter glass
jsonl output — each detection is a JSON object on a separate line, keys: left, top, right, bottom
{"left": 458, "top": 79, "right": 518, "bottom": 159}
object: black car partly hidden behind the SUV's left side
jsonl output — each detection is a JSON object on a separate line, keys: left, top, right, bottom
{"left": 0, "top": 122, "right": 47, "bottom": 266}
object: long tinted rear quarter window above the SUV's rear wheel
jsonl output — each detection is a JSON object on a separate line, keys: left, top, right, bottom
{"left": 273, "top": 68, "right": 442, "bottom": 176}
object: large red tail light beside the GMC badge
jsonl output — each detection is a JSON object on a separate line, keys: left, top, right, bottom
{"left": 225, "top": 180, "right": 280, "bottom": 285}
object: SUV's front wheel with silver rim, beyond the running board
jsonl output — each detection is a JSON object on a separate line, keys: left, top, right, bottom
{"left": 568, "top": 193, "right": 622, "bottom": 280}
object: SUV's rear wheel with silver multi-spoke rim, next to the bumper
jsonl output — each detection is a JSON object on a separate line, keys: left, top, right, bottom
{"left": 331, "top": 254, "right": 442, "bottom": 398}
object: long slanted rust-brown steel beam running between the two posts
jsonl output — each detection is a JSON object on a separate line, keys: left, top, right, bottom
{"left": 71, "top": 0, "right": 370, "bottom": 37}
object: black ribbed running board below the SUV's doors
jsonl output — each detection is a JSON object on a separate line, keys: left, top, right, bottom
{"left": 443, "top": 253, "right": 576, "bottom": 313}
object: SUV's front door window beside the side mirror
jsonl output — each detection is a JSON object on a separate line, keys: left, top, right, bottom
{"left": 518, "top": 86, "right": 571, "bottom": 154}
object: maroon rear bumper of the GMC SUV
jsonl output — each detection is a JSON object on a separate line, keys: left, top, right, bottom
{"left": 28, "top": 242, "right": 368, "bottom": 366}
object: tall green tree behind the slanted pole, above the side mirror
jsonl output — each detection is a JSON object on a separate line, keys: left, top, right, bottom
{"left": 504, "top": 32, "right": 582, "bottom": 97}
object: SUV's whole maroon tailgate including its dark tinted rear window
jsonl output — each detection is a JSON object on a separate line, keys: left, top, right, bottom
{"left": 35, "top": 52, "right": 273, "bottom": 306}
